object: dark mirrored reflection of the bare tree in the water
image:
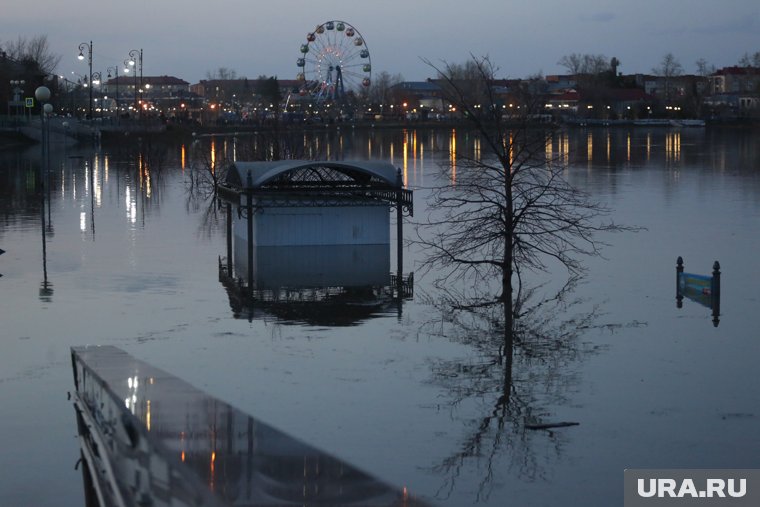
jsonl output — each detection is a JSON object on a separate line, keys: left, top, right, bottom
{"left": 424, "top": 285, "right": 616, "bottom": 502}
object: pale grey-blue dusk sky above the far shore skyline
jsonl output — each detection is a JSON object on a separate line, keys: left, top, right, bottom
{"left": 0, "top": 0, "right": 760, "bottom": 83}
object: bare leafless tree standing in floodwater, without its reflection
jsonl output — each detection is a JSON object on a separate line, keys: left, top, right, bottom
{"left": 417, "top": 57, "right": 623, "bottom": 356}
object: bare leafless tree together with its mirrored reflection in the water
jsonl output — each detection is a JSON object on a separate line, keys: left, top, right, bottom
{"left": 417, "top": 58, "right": 638, "bottom": 502}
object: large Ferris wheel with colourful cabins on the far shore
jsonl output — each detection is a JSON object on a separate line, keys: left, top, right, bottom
{"left": 296, "top": 20, "right": 372, "bottom": 102}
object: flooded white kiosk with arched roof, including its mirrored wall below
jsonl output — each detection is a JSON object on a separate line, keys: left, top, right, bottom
{"left": 214, "top": 160, "right": 413, "bottom": 322}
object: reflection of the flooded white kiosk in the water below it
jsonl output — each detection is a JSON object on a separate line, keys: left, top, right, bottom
{"left": 219, "top": 198, "right": 413, "bottom": 326}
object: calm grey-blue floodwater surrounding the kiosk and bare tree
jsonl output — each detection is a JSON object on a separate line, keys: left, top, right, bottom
{"left": 0, "top": 128, "right": 760, "bottom": 507}
